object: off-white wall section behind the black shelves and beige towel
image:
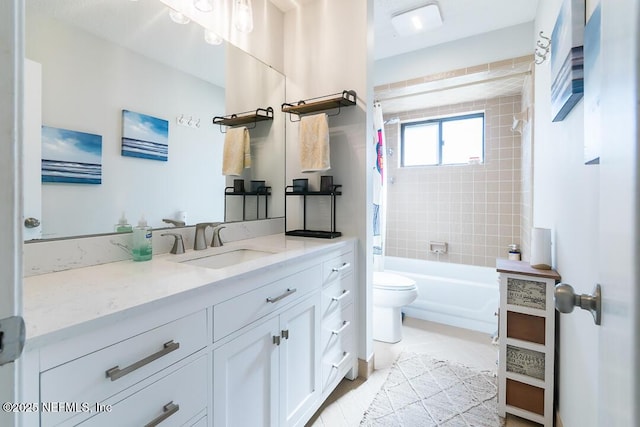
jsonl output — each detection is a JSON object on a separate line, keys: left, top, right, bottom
{"left": 284, "top": 0, "right": 373, "bottom": 368}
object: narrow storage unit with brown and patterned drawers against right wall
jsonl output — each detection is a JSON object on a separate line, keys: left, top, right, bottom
{"left": 496, "top": 259, "right": 560, "bottom": 427}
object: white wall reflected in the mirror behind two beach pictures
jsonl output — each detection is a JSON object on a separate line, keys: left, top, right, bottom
{"left": 26, "top": 16, "right": 225, "bottom": 238}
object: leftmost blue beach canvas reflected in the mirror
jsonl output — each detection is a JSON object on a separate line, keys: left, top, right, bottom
{"left": 42, "top": 126, "right": 102, "bottom": 184}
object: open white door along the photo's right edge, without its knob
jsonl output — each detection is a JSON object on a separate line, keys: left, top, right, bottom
{"left": 596, "top": 0, "right": 640, "bottom": 427}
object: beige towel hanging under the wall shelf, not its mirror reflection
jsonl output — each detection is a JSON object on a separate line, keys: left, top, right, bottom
{"left": 299, "top": 113, "right": 331, "bottom": 172}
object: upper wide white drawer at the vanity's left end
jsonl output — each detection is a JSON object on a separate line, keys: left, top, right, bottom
{"left": 40, "top": 310, "right": 207, "bottom": 425}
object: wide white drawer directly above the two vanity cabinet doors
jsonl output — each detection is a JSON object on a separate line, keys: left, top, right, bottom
{"left": 213, "top": 265, "right": 322, "bottom": 341}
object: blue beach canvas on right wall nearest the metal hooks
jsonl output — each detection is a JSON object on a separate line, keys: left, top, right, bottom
{"left": 551, "top": 0, "right": 585, "bottom": 122}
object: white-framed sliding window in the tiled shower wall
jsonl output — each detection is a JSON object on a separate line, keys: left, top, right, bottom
{"left": 400, "top": 113, "right": 484, "bottom": 166}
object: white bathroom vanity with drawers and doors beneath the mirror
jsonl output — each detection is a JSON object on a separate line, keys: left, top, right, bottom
{"left": 21, "top": 236, "right": 357, "bottom": 427}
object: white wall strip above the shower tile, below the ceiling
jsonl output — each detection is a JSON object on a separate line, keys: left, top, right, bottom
{"left": 373, "top": 22, "right": 537, "bottom": 86}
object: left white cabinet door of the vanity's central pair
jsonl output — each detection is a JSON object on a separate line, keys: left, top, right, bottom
{"left": 213, "top": 317, "right": 280, "bottom": 427}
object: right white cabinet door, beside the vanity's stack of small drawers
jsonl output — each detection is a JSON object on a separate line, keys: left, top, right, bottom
{"left": 280, "top": 292, "right": 321, "bottom": 426}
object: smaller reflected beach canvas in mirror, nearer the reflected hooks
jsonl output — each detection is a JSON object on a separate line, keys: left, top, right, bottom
{"left": 122, "top": 110, "right": 169, "bottom": 162}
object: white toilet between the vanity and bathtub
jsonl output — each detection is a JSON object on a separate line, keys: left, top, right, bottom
{"left": 373, "top": 271, "right": 418, "bottom": 343}
